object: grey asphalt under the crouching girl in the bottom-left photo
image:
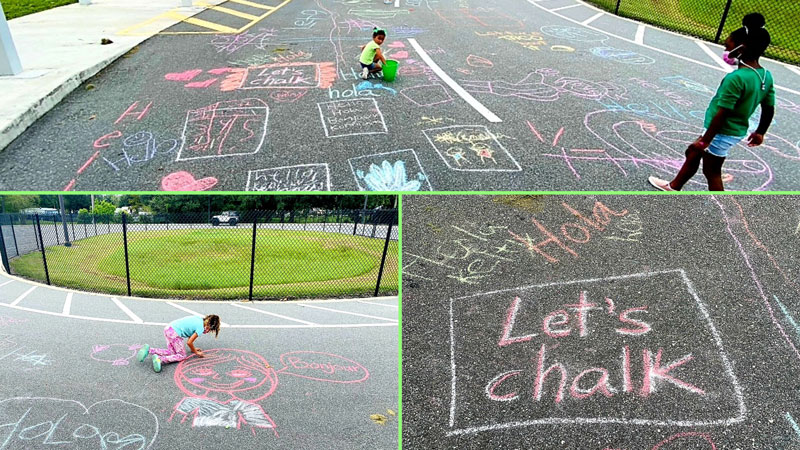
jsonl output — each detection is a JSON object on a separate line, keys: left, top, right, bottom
{"left": 0, "top": 275, "right": 398, "bottom": 450}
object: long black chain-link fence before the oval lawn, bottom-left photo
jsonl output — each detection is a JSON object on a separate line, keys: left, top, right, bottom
{"left": 0, "top": 208, "right": 399, "bottom": 299}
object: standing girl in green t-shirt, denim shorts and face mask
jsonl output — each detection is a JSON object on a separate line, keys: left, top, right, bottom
{"left": 648, "top": 13, "right": 775, "bottom": 191}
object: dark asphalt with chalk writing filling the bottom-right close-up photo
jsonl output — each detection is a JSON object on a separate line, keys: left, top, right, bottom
{"left": 402, "top": 196, "right": 800, "bottom": 450}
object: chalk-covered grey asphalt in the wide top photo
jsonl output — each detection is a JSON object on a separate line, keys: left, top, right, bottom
{"left": 0, "top": 0, "right": 800, "bottom": 191}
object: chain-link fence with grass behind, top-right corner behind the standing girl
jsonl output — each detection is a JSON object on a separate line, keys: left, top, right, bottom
{"left": 588, "top": 0, "right": 800, "bottom": 64}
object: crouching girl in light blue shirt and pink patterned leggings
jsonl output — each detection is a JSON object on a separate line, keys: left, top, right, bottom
{"left": 136, "top": 314, "right": 220, "bottom": 372}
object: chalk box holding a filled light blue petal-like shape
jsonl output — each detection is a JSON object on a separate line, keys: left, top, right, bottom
{"left": 348, "top": 149, "right": 433, "bottom": 191}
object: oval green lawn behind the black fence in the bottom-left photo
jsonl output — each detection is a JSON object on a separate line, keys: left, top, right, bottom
{"left": 10, "top": 229, "right": 398, "bottom": 299}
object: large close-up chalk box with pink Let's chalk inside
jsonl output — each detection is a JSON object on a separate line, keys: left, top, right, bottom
{"left": 448, "top": 269, "right": 747, "bottom": 436}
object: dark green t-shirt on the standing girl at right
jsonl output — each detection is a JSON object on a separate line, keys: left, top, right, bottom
{"left": 705, "top": 67, "right": 775, "bottom": 137}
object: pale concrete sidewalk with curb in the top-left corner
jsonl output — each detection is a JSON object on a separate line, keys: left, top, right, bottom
{"left": 0, "top": 0, "right": 224, "bottom": 151}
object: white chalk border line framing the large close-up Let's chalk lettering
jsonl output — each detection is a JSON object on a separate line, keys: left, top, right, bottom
{"left": 446, "top": 269, "right": 747, "bottom": 436}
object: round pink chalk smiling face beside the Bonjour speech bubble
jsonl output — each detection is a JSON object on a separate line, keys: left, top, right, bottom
{"left": 174, "top": 349, "right": 278, "bottom": 402}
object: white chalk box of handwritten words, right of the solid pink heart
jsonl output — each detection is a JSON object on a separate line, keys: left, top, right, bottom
{"left": 245, "top": 163, "right": 331, "bottom": 191}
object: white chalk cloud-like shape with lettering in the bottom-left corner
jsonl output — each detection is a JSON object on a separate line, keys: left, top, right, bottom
{"left": 0, "top": 397, "right": 159, "bottom": 450}
